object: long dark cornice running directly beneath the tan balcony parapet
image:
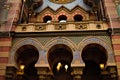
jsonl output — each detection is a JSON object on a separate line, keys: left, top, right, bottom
{"left": 11, "top": 29, "right": 111, "bottom": 37}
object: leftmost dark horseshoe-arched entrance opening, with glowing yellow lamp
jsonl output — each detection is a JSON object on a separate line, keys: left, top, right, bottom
{"left": 16, "top": 45, "right": 39, "bottom": 80}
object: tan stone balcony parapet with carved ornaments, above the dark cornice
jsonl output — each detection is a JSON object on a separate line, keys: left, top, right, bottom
{"left": 15, "top": 21, "right": 108, "bottom": 32}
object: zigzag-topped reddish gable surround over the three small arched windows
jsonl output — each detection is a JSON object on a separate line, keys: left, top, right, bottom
{"left": 37, "top": 5, "right": 89, "bottom": 22}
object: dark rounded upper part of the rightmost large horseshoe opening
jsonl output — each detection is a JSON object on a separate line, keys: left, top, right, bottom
{"left": 81, "top": 43, "right": 108, "bottom": 65}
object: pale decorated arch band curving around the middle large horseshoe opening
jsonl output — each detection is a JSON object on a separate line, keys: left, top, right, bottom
{"left": 44, "top": 37, "right": 77, "bottom": 67}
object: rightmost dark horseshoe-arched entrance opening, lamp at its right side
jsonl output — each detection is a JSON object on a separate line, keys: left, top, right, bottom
{"left": 82, "top": 44, "right": 107, "bottom": 80}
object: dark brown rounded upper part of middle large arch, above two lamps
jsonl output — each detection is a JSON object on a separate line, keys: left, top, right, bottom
{"left": 47, "top": 44, "right": 73, "bottom": 69}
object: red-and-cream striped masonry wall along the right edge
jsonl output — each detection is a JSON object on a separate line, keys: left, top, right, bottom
{"left": 104, "top": 0, "right": 120, "bottom": 80}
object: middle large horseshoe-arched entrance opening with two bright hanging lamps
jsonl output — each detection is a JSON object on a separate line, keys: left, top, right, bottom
{"left": 48, "top": 44, "right": 73, "bottom": 80}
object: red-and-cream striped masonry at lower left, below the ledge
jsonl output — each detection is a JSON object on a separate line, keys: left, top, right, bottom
{"left": 0, "top": 38, "right": 12, "bottom": 80}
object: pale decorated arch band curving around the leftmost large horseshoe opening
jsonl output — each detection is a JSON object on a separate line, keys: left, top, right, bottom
{"left": 8, "top": 37, "right": 43, "bottom": 68}
